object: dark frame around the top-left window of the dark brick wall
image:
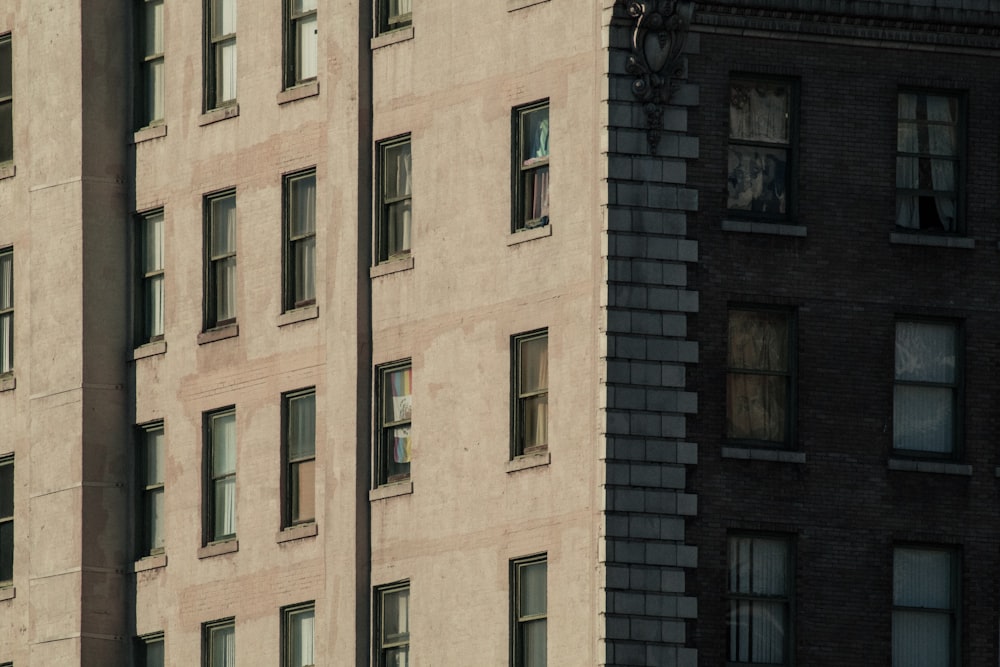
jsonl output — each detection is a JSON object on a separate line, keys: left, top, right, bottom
{"left": 725, "top": 71, "right": 800, "bottom": 224}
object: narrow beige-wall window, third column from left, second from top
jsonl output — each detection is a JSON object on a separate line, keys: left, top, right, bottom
{"left": 205, "top": 191, "right": 236, "bottom": 329}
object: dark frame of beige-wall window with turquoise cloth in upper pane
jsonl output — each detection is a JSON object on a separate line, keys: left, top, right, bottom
{"left": 510, "top": 98, "right": 552, "bottom": 233}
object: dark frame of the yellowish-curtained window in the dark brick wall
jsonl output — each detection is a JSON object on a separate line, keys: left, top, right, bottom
{"left": 723, "top": 303, "right": 798, "bottom": 450}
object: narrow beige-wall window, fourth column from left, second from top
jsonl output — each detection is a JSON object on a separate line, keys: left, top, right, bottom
{"left": 284, "top": 169, "right": 316, "bottom": 311}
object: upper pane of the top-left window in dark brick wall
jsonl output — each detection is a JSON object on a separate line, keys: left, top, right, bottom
{"left": 729, "top": 81, "right": 791, "bottom": 144}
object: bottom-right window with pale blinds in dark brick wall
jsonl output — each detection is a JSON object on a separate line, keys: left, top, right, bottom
{"left": 892, "top": 547, "right": 961, "bottom": 667}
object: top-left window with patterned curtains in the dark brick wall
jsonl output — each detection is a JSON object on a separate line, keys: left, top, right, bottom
{"left": 727, "top": 77, "right": 795, "bottom": 219}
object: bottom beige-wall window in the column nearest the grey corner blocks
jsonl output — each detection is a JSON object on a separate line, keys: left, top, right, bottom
{"left": 511, "top": 554, "right": 548, "bottom": 667}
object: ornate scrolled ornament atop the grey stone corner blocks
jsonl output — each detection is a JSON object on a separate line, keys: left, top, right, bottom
{"left": 619, "top": 0, "right": 694, "bottom": 155}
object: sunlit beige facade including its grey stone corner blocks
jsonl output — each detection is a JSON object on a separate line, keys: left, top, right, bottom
{"left": 0, "top": 0, "right": 698, "bottom": 667}
